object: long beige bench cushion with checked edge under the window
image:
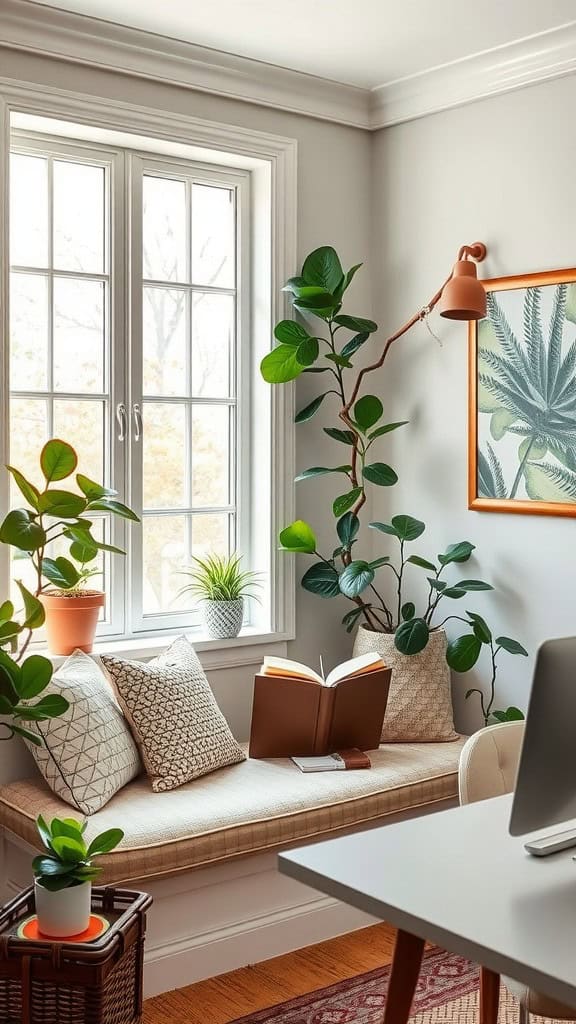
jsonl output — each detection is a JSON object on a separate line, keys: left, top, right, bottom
{"left": 0, "top": 739, "right": 464, "bottom": 882}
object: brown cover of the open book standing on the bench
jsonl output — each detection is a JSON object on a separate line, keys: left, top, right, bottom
{"left": 249, "top": 669, "right": 392, "bottom": 758}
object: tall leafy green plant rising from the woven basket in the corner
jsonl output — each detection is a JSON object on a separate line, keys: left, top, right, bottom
{"left": 260, "top": 246, "right": 526, "bottom": 717}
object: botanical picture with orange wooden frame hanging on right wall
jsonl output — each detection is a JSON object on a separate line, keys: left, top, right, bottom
{"left": 468, "top": 268, "right": 576, "bottom": 516}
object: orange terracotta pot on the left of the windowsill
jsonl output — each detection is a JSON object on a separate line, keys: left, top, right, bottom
{"left": 40, "top": 590, "right": 106, "bottom": 654}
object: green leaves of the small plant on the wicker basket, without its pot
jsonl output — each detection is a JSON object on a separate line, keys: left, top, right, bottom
{"left": 32, "top": 814, "right": 124, "bottom": 892}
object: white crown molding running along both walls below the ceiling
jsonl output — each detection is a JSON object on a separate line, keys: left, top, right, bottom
{"left": 0, "top": 0, "right": 576, "bottom": 131}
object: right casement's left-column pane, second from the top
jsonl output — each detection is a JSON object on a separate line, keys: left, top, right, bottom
{"left": 142, "top": 288, "right": 189, "bottom": 396}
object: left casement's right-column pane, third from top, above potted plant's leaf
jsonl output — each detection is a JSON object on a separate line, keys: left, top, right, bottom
{"left": 52, "top": 398, "right": 105, "bottom": 483}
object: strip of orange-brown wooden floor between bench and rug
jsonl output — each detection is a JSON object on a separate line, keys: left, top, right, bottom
{"left": 143, "top": 925, "right": 395, "bottom": 1024}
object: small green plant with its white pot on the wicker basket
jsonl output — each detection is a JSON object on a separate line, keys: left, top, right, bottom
{"left": 32, "top": 815, "right": 124, "bottom": 938}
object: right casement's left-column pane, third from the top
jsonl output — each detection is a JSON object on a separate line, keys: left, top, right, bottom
{"left": 143, "top": 401, "right": 188, "bottom": 509}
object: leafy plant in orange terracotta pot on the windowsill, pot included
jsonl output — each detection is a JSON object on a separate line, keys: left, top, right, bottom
{"left": 0, "top": 438, "right": 138, "bottom": 654}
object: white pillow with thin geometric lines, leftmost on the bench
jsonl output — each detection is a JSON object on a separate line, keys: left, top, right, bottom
{"left": 27, "top": 650, "right": 141, "bottom": 814}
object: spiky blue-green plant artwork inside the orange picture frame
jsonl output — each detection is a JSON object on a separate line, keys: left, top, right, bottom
{"left": 479, "top": 284, "right": 576, "bottom": 501}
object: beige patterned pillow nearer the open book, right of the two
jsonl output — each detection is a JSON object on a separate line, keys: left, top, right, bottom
{"left": 101, "top": 637, "right": 246, "bottom": 793}
